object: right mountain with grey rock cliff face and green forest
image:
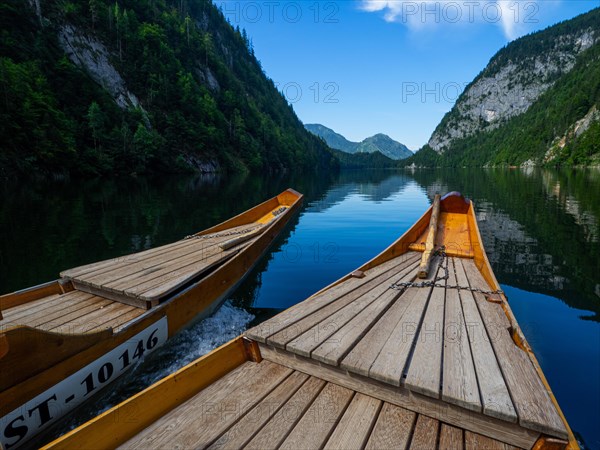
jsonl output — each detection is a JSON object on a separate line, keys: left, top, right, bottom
{"left": 403, "top": 8, "right": 600, "bottom": 166}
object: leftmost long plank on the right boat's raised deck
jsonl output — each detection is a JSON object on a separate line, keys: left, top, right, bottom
{"left": 245, "top": 252, "right": 419, "bottom": 345}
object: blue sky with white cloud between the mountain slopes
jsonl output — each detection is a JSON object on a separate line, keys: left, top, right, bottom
{"left": 220, "top": 0, "right": 600, "bottom": 150}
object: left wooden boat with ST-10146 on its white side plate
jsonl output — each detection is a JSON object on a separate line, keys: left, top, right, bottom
{"left": 0, "top": 189, "right": 302, "bottom": 449}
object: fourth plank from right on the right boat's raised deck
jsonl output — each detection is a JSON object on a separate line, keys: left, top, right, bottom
{"left": 404, "top": 259, "right": 448, "bottom": 398}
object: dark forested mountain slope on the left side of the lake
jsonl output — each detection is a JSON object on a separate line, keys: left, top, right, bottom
{"left": 0, "top": 0, "right": 337, "bottom": 177}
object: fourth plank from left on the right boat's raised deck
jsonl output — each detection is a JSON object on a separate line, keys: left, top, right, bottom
{"left": 311, "top": 262, "right": 417, "bottom": 366}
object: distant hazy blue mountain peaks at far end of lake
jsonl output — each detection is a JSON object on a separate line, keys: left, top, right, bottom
{"left": 304, "top": 123, "right": 413, "bottom": 160}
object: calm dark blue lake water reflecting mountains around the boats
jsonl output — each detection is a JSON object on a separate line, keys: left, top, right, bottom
{"left": 0, "top": 169, "right": 600, "bottom": 448}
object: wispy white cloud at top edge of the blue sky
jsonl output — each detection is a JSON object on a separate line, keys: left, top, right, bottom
{"left": 360, "top": 0, "right": 556, "bottom": 40}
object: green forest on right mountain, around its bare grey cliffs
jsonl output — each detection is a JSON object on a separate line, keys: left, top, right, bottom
{"left": 400, "top": 9, "right": 600, "bottom": 171}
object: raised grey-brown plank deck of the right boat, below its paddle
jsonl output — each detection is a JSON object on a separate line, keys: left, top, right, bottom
{"left": 246, "top": 252, "right": 568, "bottom": 439}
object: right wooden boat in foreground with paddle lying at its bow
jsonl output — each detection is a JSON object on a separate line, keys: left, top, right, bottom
{"left": 46, "top": 193, "right": 578, "bottom": 449}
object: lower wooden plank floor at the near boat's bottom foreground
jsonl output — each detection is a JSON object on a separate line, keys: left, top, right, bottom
{"left": 121, "top": 360, "right": 517, "bottom": 450}
